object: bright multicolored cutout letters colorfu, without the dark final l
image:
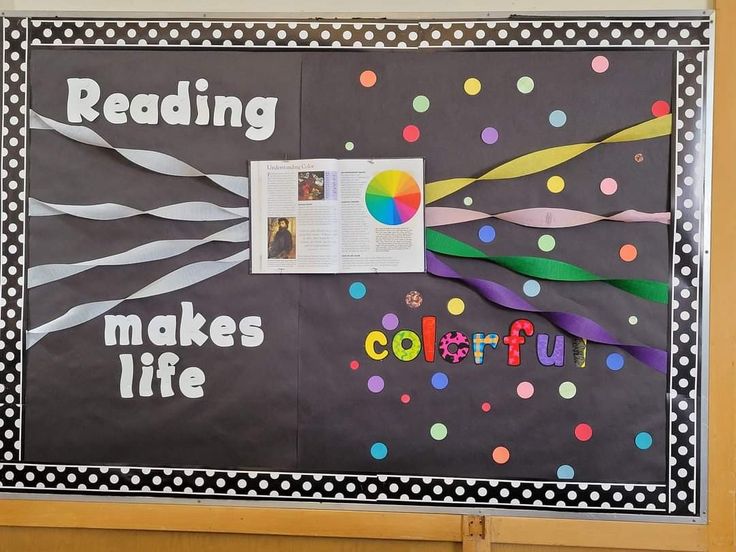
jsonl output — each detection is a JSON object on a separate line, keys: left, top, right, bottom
{"left": 365, "top": 316, "right": 565, "bottom": 366}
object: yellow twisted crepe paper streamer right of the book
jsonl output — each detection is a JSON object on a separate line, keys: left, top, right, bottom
{"left": 424, "top": 113, "right": 672, "bottom": 205}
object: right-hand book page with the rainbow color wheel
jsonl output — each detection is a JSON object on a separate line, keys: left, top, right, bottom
{"left": 339, "top": 159, "right": 424, "bottom": 272}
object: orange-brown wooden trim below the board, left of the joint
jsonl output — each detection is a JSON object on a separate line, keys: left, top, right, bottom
{"left": 0, "top": 499, "right": 462, "bottom": 542}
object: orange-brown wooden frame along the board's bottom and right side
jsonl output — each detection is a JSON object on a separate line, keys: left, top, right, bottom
{"left": 0, "top": 1, "right": 736, "bottom": 551}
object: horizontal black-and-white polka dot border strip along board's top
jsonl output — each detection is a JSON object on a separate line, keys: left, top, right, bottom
{"left": 25, "top": 17, "right": 711, "bottom": 48}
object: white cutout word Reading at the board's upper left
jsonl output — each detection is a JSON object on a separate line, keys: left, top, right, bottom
{"left": 66, "top": 78, "right": 278, "bottom": 141}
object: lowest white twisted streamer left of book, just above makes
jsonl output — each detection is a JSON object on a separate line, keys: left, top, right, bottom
{"left": 26, "top": 249, "right": 250, "bottom": 349}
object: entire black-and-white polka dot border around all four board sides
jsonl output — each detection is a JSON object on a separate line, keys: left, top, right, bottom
{"left": 0, "top": 18, "right": 710, "bottom": 518}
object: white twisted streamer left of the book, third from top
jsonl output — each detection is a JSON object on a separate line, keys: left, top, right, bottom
{"left": 26, "top": 222, "right": 250, "bottom": 289}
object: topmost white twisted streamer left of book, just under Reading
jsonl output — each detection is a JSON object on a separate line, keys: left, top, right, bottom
{"left": 29, "top": 110, "right": 248, "bottom": 197}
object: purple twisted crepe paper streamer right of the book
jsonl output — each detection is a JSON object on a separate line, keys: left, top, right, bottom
{"left": 427, "top": 251, "right": 669, "bottom": 374}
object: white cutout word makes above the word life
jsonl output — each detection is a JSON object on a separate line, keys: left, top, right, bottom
{"left": 105, "top": 302, "right": 263, "bottom": 347}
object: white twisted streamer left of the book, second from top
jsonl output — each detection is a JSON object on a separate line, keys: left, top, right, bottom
{"left": 28, "top": 197, "right": 250, "bottom": 222}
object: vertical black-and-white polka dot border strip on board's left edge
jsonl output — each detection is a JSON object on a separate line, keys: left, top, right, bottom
{"left": 0, "top": 18, "right": 28, "bottom": 462}
